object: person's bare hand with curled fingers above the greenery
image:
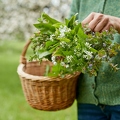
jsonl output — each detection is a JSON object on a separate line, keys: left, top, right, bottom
{"left": 82, "top": 12, "right": 120, "bottom": 33}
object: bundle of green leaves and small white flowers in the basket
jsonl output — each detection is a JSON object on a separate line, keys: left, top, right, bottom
{"left": 31, "top": 13, "right": 120, "bottom": 76}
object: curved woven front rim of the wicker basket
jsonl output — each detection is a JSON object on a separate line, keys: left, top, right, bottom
{"left": 17, "top": 63, "right": 81, "bottom": 81}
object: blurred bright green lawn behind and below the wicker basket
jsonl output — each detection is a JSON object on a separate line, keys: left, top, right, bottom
{"left": 0, "top": 40, "right": 77, "bottom": 120}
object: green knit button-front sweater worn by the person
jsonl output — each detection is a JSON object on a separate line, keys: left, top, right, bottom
{"left": 70, "top": 0, "right": 120, "bottom": 105}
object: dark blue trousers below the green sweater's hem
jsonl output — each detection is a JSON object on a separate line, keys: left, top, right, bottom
{"left": 77, "top": 104, "right": 120, "bottom": 120}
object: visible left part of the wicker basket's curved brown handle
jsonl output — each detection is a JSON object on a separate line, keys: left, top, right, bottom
{"left": 20, "top": 40, "right": 31, "bottom": 64}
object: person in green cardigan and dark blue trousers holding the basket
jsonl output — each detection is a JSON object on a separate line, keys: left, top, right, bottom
{"left": 70, "top": 0, "right": 120, "bottom": 120}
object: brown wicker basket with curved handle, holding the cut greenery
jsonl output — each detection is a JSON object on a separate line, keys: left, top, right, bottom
{"left": 17, "top": 41, "right": 80, "bottom": 111}
